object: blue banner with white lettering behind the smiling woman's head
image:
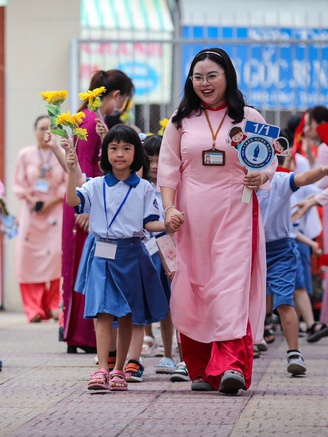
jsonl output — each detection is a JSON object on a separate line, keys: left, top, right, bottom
{"left": 182, "top": 26, "right": 328, "bottom": 111}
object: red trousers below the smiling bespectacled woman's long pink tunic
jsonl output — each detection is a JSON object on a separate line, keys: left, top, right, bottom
{"left": 180, "top": 323, "right": 253, "bottom": 390}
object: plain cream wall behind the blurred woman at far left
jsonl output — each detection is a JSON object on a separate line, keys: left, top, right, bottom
{"left": 4, "top": 0, "right": 80, "bottom": 311}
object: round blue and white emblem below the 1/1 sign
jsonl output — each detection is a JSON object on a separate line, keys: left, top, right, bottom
{"left": 238, "top": 136, "right": 274, "bottom": 171}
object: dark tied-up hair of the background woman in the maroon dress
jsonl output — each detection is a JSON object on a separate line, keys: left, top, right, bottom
{"left": 78, "top": 70, "right": 134, "bottom": 111}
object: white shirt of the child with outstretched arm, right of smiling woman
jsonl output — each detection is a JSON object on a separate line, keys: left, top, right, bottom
{"left": 257, "top": 172, "right": 298, "bottom": 243}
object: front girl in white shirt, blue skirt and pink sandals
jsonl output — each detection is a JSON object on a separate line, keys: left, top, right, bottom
{"left": 67, "top": 125, "right": 183, "bottom": 390}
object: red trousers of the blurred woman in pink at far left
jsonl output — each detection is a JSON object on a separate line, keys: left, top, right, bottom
{"left": 19, "top": 279, "right": 60, "bottom": 321}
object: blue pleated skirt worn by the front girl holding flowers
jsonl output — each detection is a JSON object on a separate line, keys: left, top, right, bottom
{"left": 83, "top": 238, "right": 169, "bottom": 325}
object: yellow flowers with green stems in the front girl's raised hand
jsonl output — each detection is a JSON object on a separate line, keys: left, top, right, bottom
{"left": 41, "top": 90, "right": 87, "bottom": 140}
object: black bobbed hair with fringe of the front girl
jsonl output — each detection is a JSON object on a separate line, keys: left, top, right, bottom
{"left": 100, "top": 124, "right": 144, "bottom": 173}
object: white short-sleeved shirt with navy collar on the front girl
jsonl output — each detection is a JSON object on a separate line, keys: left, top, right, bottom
{"left": 76, "top": 173, "right": 159, "bottom": 239}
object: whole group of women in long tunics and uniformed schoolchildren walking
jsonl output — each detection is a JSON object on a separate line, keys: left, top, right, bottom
{"left": 3, "top": 48, "right": 328, "bottom": 394}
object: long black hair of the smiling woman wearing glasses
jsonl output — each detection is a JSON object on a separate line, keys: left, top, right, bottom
{"left": 172, "top": 48, "right": 245, "bottom": 129}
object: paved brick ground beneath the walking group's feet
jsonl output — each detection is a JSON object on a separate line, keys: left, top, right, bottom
{"left": 0, "top": 312, "right": 328, "bottom": 437}
